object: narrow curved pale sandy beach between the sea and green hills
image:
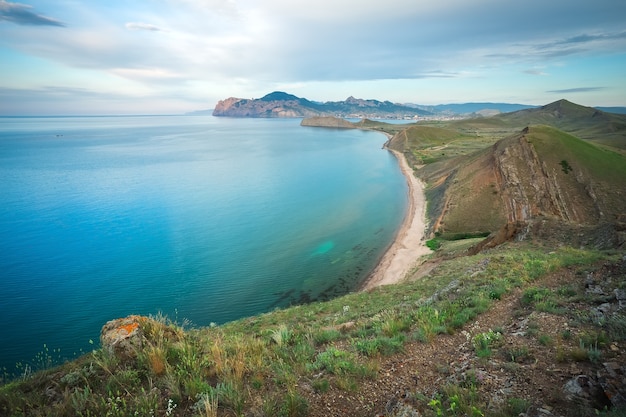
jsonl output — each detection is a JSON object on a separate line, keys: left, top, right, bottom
{"left": 359, "top": 133, "right": 431, "bottom": 291}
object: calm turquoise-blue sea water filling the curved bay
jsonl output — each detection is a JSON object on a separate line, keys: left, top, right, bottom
{"left": 0, "top": 116, "right": 407, "bottom": 369}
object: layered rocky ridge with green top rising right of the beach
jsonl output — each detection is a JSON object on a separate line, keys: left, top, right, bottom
{"left": 422, "top": 126, "right": 626, "bottom": 245}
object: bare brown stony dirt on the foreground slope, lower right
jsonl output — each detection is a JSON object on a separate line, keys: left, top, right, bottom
{"left": 299, "top": 262, "right": 626, "bottom": 417}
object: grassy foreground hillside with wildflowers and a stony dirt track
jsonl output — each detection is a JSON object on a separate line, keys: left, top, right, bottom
{"left": 0, "top": 244, "right": 626, "bottom": 416}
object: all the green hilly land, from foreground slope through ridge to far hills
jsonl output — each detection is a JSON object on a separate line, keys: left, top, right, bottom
{"left": 0, "top": 100, "right": 626, "bottom": 417}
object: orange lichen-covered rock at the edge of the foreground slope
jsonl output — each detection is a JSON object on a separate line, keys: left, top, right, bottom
{"left": 100, "top": 315, "right": 149, "bottom": 359}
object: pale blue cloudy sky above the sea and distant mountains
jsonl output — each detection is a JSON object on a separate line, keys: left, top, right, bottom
{"left": 0, "top": 0, "right": 626, "bottom": 115}
